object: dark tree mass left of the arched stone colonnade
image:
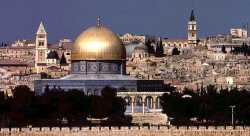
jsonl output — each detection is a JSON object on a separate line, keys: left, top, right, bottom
{"left": 0, "top": 85, "right": 131, "bottom": 127}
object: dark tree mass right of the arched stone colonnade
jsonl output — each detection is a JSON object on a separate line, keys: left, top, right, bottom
{"left": 161, "top": 85, "right": 250, "bottom": 125}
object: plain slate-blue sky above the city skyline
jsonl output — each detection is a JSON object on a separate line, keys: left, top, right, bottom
{"left": 0, "top": 0, "right": 250, "bottom": 42}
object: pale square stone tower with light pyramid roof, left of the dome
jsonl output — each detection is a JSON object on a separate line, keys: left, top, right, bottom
{"left": 35, "top": 22, "right": 48, "bottom": 73}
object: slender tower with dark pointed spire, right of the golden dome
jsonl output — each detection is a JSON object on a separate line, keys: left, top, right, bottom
{"left": 188, "top": 10, "right": 198, "bottom": 47}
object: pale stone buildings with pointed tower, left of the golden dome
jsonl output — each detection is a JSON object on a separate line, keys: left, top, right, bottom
{"left": 0, "top": 23, "right": 72, "bottom": 95}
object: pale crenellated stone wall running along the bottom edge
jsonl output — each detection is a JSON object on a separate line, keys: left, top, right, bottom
{"left": 0, "top": 126, "right": 250, "bottom": 136}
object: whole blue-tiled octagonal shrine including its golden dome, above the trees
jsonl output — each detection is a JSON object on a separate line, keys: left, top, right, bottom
{"left": 34, "top": 19, "right": 164, "bottom": 95}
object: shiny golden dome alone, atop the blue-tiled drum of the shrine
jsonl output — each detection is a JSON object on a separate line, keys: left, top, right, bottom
{"left": 71, "top": 25, "right": 126, "bottom": 60}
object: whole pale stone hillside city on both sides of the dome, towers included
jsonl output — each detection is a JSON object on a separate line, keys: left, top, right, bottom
{"left": 0, "top": 11, "right": 250, "bottom": 94}
